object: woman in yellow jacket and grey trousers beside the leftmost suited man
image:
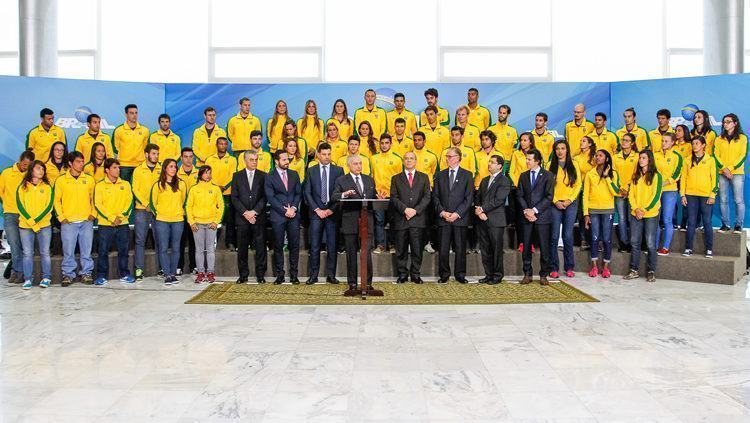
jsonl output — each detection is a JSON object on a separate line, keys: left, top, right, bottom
{"left": 185, "top": 166, "right": 224, "bottom": 283}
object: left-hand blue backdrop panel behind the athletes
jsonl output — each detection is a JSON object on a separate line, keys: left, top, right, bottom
{"left": 0, "top": 76, "right": 164, "bottom": 168}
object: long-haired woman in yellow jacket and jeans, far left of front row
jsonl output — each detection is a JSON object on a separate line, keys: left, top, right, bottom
{"left": 16, "top": 160, "right": 54, "bottom": 289}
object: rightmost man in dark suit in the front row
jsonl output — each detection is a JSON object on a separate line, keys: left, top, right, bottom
{"left": 516, "top": 149, "right": 557, "bottom": 285}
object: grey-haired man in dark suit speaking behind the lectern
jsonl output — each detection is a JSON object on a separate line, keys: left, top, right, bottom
{"left": 331, "top": 154, "right": 377, "bottom": 289}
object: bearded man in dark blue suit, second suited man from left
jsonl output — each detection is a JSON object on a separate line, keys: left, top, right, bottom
{"left": 265, "top": 150, "right": 302, "bottom": 285}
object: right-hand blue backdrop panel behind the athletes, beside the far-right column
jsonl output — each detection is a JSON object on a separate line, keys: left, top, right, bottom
{"left": 610, "top": 74, "right": 750, "bottom": 226}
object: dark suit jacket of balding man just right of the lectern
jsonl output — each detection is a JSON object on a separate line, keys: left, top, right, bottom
{"left": 391, "top": 171, "right": 431, "bottom": 230}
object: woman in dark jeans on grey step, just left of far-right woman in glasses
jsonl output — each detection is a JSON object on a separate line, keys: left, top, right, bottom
{"left": 680, "top": 135, "right": 719, "bottom": 258}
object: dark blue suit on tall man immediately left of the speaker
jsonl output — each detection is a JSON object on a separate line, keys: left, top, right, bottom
{"left": 303, "top": 164, "right": 344, "bottom": 279}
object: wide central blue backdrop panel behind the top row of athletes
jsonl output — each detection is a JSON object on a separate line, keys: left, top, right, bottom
{"left": 165, "top": 83, "right": 610, "bottom": 150}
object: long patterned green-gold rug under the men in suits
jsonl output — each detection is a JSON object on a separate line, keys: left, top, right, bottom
{"left": 185, "top": 281, "right": 599, "bottom": 305}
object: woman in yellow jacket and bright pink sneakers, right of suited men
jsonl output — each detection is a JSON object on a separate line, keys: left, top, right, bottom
{"left": 583, "top": 149, "right": 620, "bottom": 278}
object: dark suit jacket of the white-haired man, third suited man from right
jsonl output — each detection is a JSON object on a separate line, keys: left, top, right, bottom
{"left": 432, "top": 167, "right": 474, "bottom": 226}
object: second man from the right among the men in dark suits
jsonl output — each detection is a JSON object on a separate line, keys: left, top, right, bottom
{"left": 474, "top": 154, "right": 511, "bottom": 285}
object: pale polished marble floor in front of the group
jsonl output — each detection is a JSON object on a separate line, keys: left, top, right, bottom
{"left": 0, "top": 274, "right": 750, "bottom": 423}
